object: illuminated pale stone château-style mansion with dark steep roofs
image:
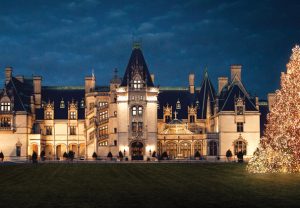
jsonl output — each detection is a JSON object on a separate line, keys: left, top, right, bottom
{"left": 0, "top": 45, "right": 272, "bottom": 160}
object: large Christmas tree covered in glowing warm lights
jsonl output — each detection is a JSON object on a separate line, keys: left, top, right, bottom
{"left": 247, "top": 45, "right": 300, "bottom": 173}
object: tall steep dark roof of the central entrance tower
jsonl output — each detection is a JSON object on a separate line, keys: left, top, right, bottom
{"left": 121, "top": 48, "right": 154, "bottom": 87}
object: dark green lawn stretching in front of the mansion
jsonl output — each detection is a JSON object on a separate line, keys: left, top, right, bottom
{"left": 0, "top": 163, "right": 300, "bottom": 208}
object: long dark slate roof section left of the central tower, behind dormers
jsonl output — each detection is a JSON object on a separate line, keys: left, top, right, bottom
{"left": 36, "top": 87, "right": 85, "bottom": 120}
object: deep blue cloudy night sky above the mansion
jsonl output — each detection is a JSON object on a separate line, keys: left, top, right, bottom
{"left": 0, "top": 0, "right": 300, "bottom": 98}
